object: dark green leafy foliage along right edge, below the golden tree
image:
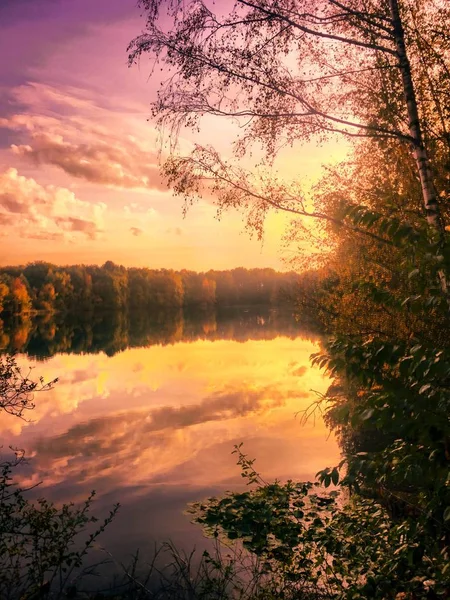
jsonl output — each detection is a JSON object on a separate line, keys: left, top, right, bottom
{"left": 304, "top": 225, "right": 450, "bottom": 597}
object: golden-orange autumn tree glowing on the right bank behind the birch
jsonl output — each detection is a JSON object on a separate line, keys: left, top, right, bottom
{"left": 288, "top": 140, "right": 446, "bottom": 342}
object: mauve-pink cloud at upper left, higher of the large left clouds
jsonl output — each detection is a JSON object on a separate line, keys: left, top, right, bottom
{"left": 0, "top": 82, "right": 167, "bottom": 191}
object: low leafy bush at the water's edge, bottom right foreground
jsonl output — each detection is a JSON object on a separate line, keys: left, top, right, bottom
{"left": 190, "top": 448, "right": 450, "bottom": 599}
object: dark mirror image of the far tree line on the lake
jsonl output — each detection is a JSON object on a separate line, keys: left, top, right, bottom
{"left": 0, "top": 307, "right": 316, "bottom": 358}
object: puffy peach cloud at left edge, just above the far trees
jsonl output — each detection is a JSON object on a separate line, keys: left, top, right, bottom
{"left": 0, "top": 169, "right": 106, "bottom": 240}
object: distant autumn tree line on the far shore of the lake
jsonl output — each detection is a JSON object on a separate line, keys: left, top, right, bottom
{"left": 0, "top": 261, "right": 298, "bottom": 315}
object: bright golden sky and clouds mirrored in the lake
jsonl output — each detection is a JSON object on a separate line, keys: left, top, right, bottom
{"left": 5, "top": 337, "right": 338, "bottom": 516}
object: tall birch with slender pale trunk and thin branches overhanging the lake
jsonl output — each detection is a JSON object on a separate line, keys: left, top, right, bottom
{"left": 129, "top": 0, "right": 450, "bottom": 253}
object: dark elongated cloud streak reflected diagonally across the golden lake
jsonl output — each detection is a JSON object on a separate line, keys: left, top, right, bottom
{"left": 33, "top": 386, "right": 305, "bottom": 481}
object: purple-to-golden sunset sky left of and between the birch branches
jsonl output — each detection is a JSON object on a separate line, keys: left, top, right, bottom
{"left": 0, "top": 0, "right": 343, "bottom": 271}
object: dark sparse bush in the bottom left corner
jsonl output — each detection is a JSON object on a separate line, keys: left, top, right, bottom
{"left": 0, "top": 456, "right": 119, "bottom": 600}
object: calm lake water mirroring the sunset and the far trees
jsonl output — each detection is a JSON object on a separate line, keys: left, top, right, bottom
{"left": 0, "top": 309, "right": 338, "bottom": 559}
